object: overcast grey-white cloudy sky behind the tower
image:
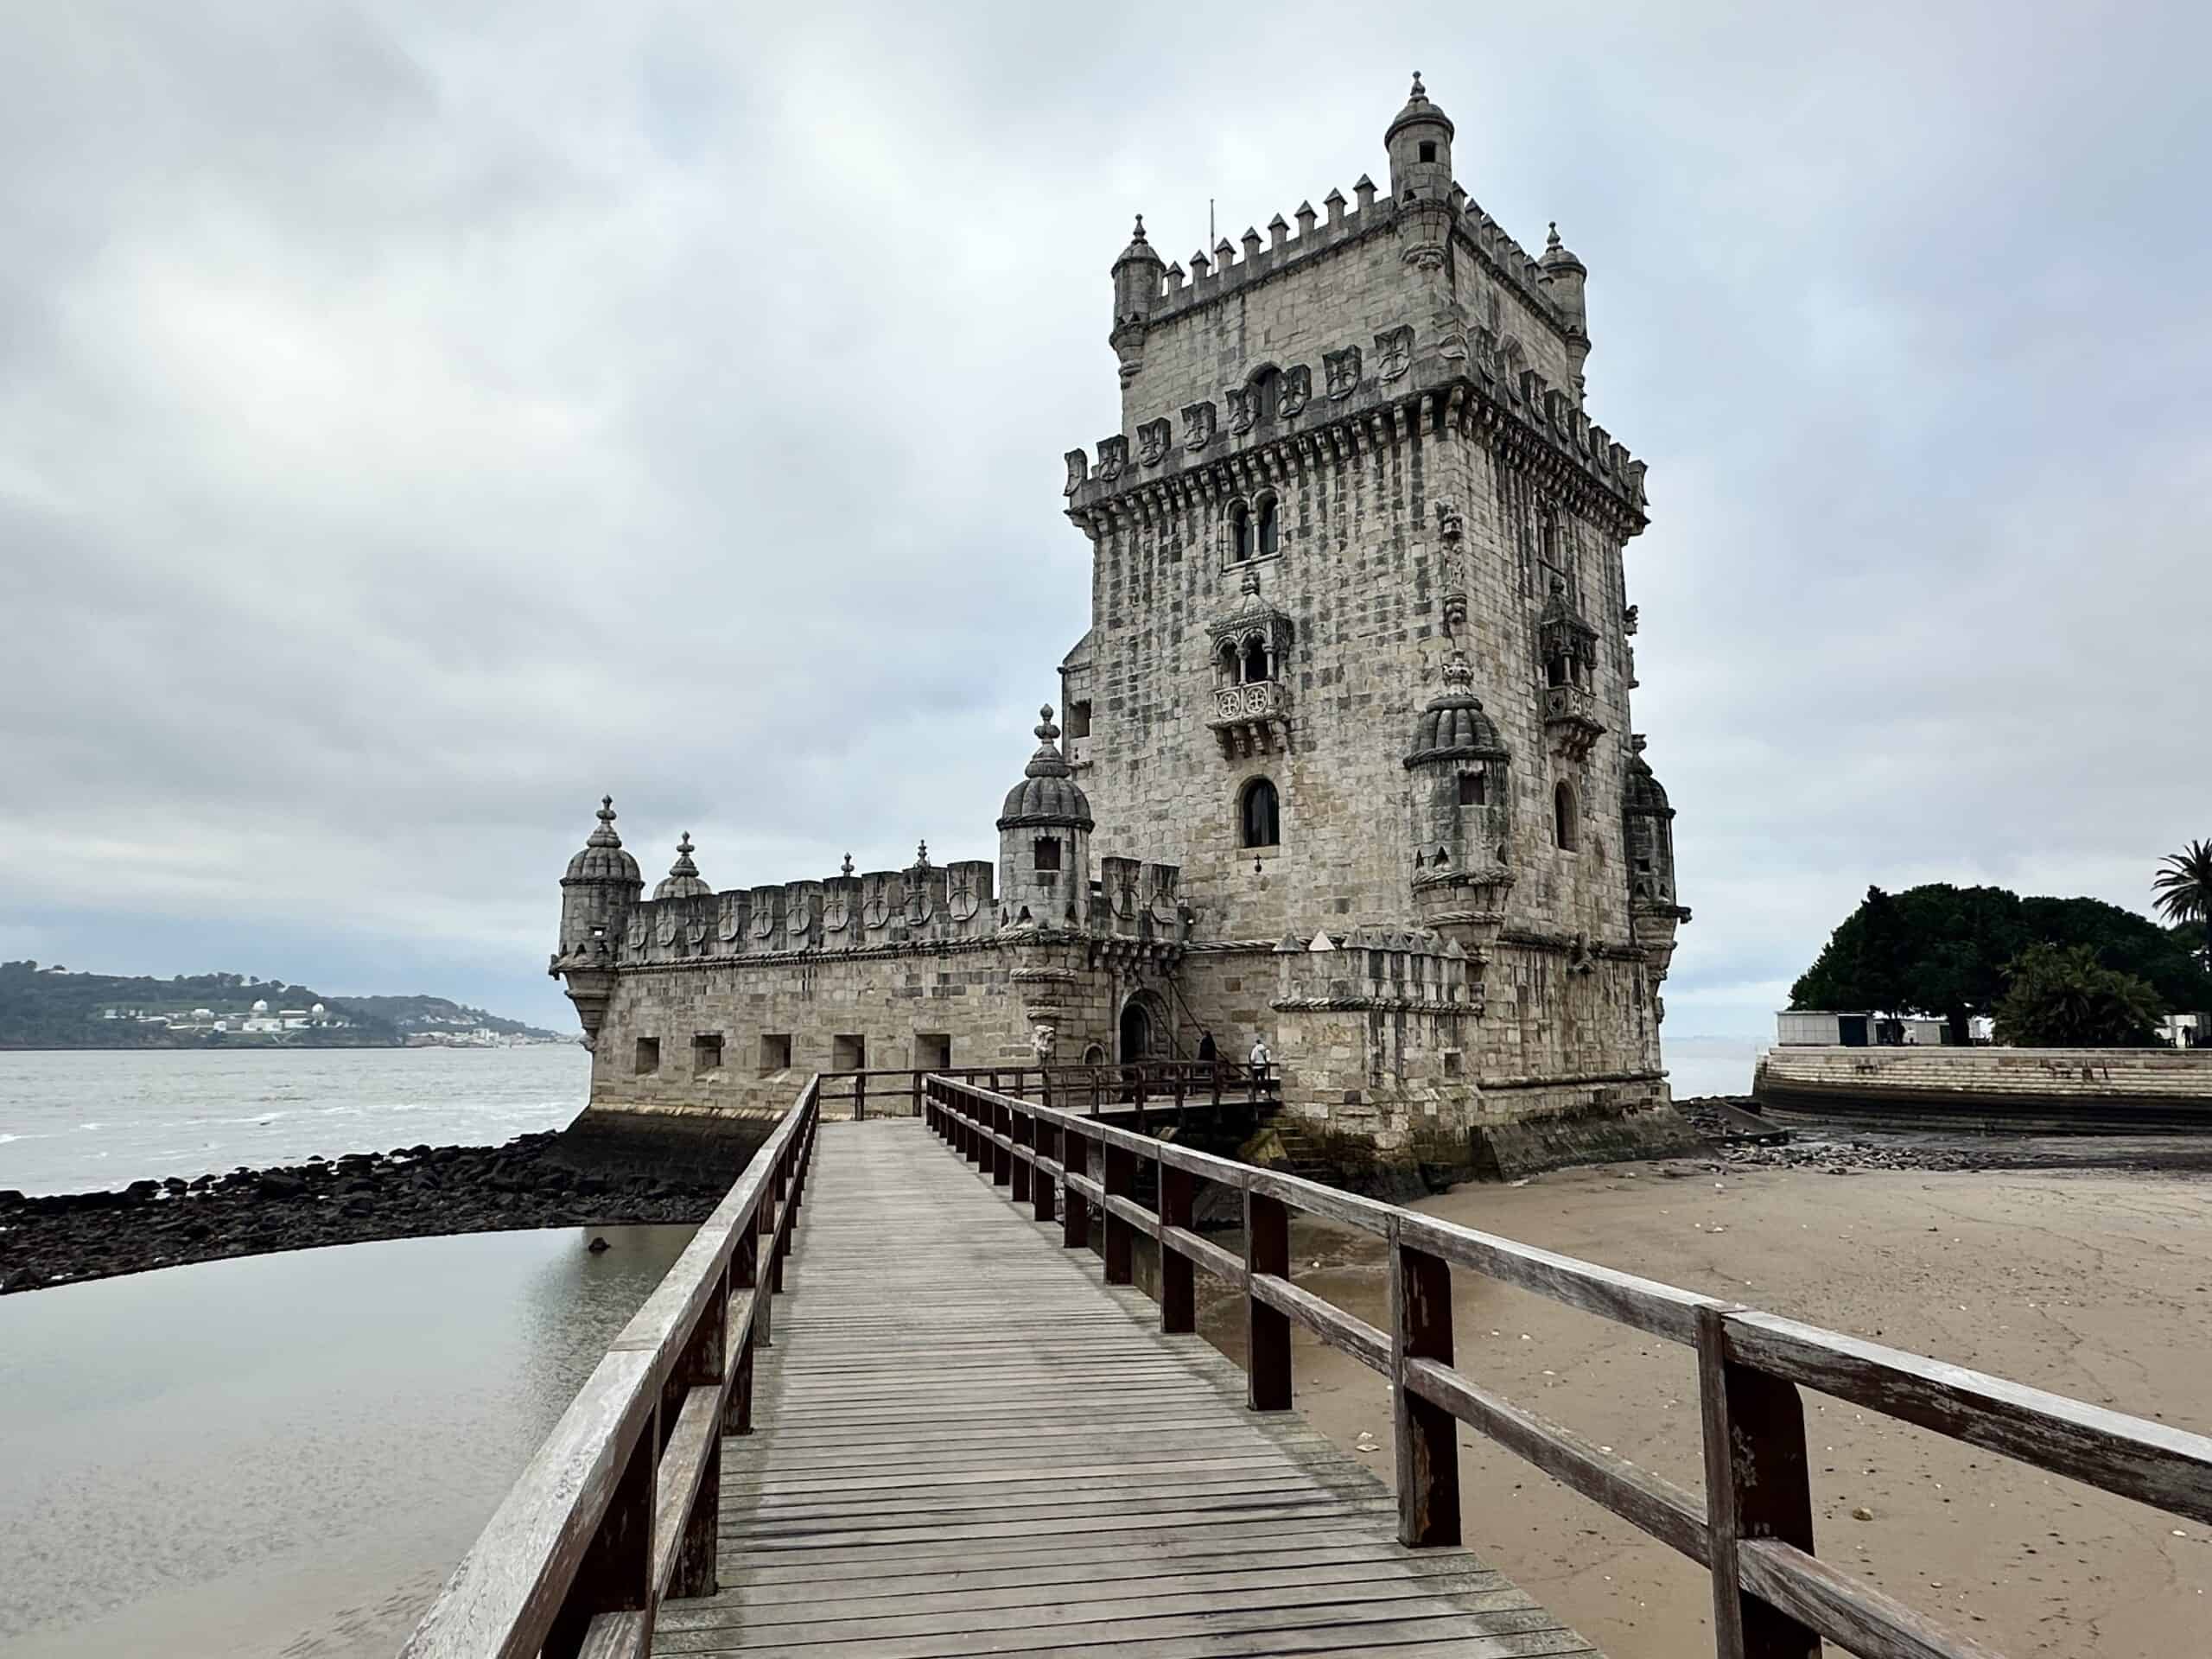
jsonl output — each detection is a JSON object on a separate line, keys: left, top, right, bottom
{"left": 0, "top": 0, "right": 2212, "bottom": 1038}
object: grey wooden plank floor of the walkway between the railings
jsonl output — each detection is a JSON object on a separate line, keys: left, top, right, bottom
{"left": 652, "top": 1119, "right": 1595, "bottom": 1659}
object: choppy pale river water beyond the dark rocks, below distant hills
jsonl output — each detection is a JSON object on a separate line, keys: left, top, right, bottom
{"left": 0, "top": 1044, "right": 591, "bottom": 1192}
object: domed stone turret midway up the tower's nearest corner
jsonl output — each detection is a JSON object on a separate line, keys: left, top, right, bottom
{"left": 1405, "top": 652, "right": 1513, "bottom": 960}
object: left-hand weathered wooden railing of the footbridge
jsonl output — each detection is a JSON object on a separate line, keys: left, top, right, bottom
{"left": 400, "top": 1082, "right": 821, "bottom": 1659}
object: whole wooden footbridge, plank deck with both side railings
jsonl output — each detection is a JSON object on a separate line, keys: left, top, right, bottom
{"left": 403, "top": 1075, "right": 2212, "bottom": 1659}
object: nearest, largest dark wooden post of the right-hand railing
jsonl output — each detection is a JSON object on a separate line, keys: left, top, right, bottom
{"left": 1697, "top": 1307, "right": 1821, "bottom": 1659}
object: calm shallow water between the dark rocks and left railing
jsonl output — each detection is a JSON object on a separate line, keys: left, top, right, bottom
{"left": 0, "top": 1228, "right": 690, "bottom": 1659}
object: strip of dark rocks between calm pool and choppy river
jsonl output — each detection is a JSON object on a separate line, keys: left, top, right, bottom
{"left": 0, "top": 1130, "right": 732, "bottom": 1294}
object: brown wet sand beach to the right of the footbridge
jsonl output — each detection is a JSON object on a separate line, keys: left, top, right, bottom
{"left": 1205, "top": 1166, "right": 2212, "bottom": 1659}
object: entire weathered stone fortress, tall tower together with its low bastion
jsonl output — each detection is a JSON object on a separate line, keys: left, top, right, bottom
{"left": 553, "top": 82, "right": 1688, "bottom": 1161}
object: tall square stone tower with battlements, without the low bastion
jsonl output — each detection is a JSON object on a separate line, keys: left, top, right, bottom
{"left": 1062, "top": 75, "right": 1688, "bottom": 1122}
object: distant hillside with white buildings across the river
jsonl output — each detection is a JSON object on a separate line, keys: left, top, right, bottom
{"left": 0, "top": 963, "right": 570, "bottom": 1048}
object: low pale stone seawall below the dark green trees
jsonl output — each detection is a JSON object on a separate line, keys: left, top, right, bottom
{"left": 1752, "top": 1048, "right": 2212, "bottom": 1135}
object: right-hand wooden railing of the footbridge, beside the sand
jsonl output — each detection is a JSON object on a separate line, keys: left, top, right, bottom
{"left": 925, "top": 1077, "right": 2212, "bottom": 1659}
